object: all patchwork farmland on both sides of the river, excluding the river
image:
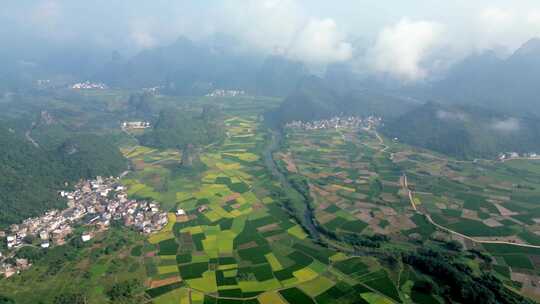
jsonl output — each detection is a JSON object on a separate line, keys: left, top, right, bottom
{"left": 117, "top": 95, "right": 540, "bottom": 304}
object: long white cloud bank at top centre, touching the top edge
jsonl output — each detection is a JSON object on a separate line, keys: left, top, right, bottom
{"left": 219, "top": 0, "right": 352, "bottom": 64}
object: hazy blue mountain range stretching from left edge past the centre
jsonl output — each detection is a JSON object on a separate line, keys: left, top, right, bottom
{"left": 0, "top": 35, "right": 309, "bottom": 96}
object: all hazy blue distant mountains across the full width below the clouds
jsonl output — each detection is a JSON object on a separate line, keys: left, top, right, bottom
{"left": 5, "top": 33, "right": 540, "bottom": 116}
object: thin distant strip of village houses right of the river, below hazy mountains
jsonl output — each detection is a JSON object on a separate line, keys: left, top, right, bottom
{"left": 285, "top": 116, "right": 382, "bottom": 130}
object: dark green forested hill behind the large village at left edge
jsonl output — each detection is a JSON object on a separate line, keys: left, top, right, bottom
{"left": 0, "top": 125, "right": 127, "bottom": 227}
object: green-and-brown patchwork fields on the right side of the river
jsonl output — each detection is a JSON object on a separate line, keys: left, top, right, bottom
{"left": 276, "top": 129, "right": 540, "bottom": 298}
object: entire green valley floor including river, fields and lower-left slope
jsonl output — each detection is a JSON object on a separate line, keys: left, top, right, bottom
{"left": 0, "top": 98, "right": 540, "bottom": 304}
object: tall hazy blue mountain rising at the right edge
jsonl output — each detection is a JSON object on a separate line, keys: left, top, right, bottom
{"left": 428, "top": 38, "right": 540, "bottom": 116}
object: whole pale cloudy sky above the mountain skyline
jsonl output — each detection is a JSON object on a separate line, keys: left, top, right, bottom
{"left": 0, "top": 0, "right": 540, "bottom": 81}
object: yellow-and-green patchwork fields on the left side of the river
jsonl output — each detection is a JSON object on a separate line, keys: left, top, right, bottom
{"left": 124, "top": 112, "right": 410, "bottom": 304}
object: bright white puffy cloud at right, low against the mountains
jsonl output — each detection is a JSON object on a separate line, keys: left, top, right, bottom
{"left": 368, "top": 18, "right": 444, "bottom": 81}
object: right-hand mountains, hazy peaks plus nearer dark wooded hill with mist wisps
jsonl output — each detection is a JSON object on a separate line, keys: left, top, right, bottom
{"left": 269, "top": 39, "right": 540, "bottom": 158}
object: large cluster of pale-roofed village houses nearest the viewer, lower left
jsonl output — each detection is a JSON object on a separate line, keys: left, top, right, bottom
{"left": 0, "top": 177, "right": 168, "bottom": 277}
